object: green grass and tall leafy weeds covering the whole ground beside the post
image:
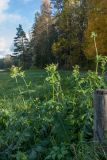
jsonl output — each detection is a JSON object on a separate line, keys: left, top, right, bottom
{"left": 0, "top": 56, "right": 107, "bottom": 160}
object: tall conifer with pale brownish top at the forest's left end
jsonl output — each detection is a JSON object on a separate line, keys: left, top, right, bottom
{"left": 31, "top": 0, "right": 55, "bottom": 68}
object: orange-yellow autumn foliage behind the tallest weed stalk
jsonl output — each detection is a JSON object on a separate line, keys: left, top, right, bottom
{"left": 84, "top": 0, "right": 107, "bottom": 59}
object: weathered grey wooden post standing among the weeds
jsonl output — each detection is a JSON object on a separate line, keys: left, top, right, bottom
{"left": 94, "top": 89, "right": 107, "bottom": 143}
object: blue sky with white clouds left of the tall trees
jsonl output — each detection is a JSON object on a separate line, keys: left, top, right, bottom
{"left": 0, "top": 0, "right": 42, "bottom": 58}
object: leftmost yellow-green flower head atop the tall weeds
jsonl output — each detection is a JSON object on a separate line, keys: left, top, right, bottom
{"left": 10, "top": 66, "right": 25, "bottom": 78}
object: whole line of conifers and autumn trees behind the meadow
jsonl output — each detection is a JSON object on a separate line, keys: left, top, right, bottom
{"left": 2, "top": 0, "right": 107, "bottom": 69}
